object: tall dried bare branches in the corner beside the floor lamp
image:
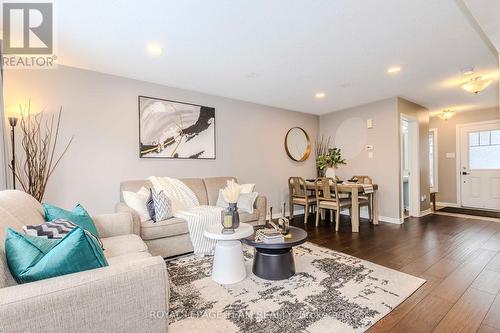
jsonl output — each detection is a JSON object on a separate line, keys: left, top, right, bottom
{"left": 11, "top": 102, "right": 73, "bottom": 202}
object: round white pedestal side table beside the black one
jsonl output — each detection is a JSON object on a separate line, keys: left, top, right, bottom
{"left": 205, "top": 223, "right": 254, "bottom": 284}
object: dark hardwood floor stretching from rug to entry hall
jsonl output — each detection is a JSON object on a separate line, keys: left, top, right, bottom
{"left": 292, "top": 211, "right": 500, "bottom": 333}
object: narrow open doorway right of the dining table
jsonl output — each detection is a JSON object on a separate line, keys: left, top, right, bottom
{"left": 400, "top": 114, "right": 420, "bottom": 219}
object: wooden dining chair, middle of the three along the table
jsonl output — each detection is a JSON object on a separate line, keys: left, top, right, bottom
{"left": 314, "top": 177, "right": 351, "bottom": 231}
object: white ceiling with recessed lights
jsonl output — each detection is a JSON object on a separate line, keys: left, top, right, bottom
{"left": 51, "top": 0, "right": 498, "bottom": 114}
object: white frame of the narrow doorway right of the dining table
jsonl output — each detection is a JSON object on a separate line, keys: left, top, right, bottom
{"left": 399, "top": 113, "right": 420, "bottom": 219}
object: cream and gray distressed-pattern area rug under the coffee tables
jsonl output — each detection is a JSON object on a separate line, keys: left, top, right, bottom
{"left": 167, "top": 243, "right": 425, "bottom": 333}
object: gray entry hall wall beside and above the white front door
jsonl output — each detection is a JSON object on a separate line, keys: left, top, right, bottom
{"left": 429, "top": 108, "right": 500, "bottom": 203}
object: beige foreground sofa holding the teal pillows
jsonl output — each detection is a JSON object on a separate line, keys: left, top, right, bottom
{"left": 0, "top": 190, "right": 169, "bottom": 333}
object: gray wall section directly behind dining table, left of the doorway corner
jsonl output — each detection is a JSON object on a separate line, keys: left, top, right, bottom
{"left": 320, "top": 98, "right": 400, "bottom": 219}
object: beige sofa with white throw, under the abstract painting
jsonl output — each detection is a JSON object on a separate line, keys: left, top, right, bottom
{"left": 116, "top": 177, "right": 267, "bottom": 257}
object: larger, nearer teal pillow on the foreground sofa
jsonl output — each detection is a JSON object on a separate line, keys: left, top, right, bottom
{"left": 5, "top": 227, "right": 108, "bottom": 283}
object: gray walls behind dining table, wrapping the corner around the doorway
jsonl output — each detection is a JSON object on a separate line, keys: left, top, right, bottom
{"left": 320, "top": 97, "right": 429, "bottom": 222}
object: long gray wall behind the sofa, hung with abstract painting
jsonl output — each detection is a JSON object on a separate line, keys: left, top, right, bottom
{"left": 4, "top": 66, "right": 319, "bottom": 213}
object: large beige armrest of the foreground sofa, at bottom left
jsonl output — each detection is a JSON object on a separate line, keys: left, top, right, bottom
{"left": 0, "top": 257, "right": 169, "bottom": 332}
